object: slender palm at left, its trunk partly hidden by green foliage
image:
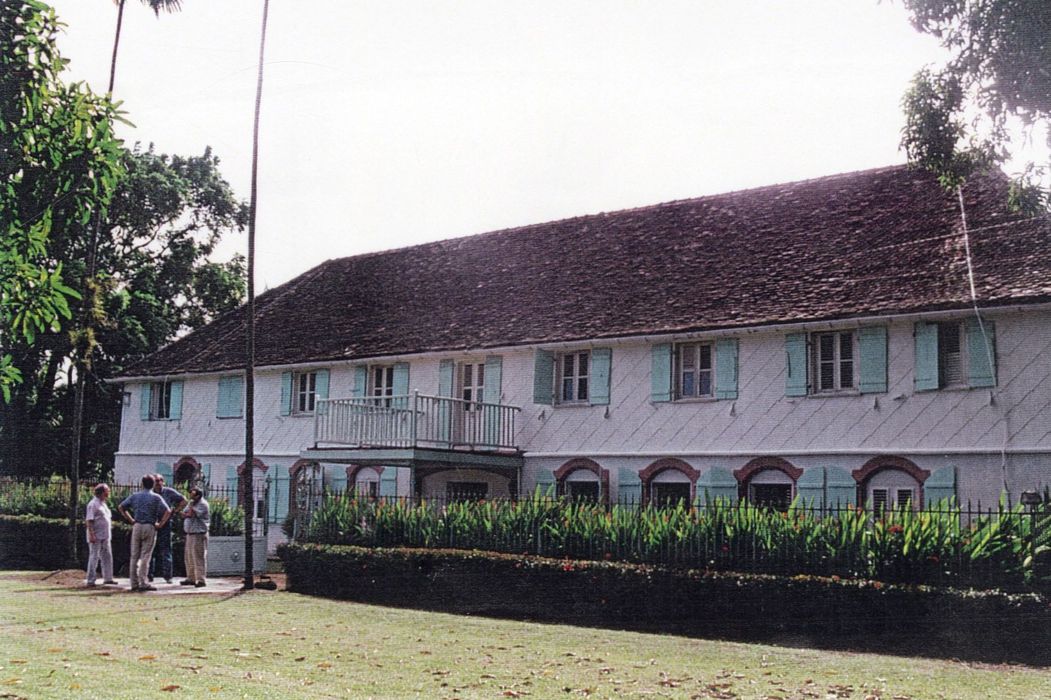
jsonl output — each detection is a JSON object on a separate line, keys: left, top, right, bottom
{"left": 69, "top": 0, "right": 182, "bottom": 561}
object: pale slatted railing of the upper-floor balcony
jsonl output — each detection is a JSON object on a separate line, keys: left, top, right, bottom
{"left": 314, "top": 392, "right": 521, "bottom": 450}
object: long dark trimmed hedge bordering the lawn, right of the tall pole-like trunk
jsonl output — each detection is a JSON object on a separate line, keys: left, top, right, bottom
{"left": 279, "top": 544, "right": 1051, "bottom": 663}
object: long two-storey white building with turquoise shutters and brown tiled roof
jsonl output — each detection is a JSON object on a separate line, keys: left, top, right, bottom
{"left": 108, "top": 167, "right": 1051, "bottom": 529}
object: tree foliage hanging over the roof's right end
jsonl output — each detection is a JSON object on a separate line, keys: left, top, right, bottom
{"left": 902, "top": 0, "right": 1051, "bottom": 212}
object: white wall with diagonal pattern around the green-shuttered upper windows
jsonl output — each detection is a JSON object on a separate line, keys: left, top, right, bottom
{"left": 117, "top": 312, "right": 1051, "bottom": 502}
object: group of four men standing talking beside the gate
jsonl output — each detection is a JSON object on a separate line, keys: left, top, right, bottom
{"left": 84, "top": 474, "right": 211, "bottom": 591}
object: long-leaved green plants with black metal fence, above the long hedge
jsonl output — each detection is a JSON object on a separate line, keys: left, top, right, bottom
{"left": 303, "top": 492, "right": 1051, "bottom": 589}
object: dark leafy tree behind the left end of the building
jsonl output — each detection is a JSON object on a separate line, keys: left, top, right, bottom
{"left": 0, "top": 146, "right": 248, "bottom": 475}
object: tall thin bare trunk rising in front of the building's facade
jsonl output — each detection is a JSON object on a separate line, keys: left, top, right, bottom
{"left": 243, "top": 0, "right": 270, "bottom": 591}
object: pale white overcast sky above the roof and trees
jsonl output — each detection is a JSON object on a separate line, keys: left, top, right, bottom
{"left": 51, "top": 0, "right": 945, "bottom": 291}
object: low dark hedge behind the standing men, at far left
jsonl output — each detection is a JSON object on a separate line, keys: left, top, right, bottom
{"left": 0, "top": 514, "right": 131, "bottom": 571}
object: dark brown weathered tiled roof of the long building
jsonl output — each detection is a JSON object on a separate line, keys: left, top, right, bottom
{"left": 119, "top": 166, "right": 1051, "bottom": 376}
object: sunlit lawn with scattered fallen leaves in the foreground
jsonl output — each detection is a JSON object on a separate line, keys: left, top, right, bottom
{"left": 0, "top": 572, "right": 1051, "bottom": 700}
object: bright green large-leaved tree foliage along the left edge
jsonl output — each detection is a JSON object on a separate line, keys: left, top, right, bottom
{"left": 0, "top": 0, "right": 122, "bottom": 402}
